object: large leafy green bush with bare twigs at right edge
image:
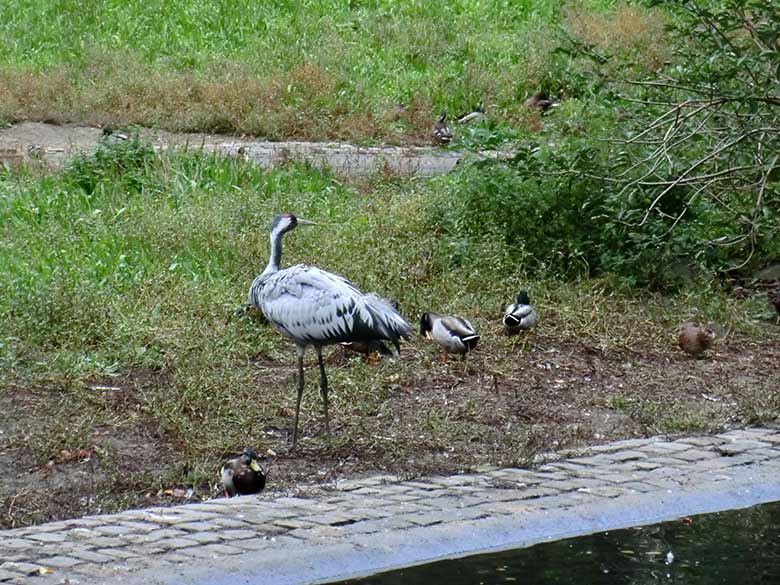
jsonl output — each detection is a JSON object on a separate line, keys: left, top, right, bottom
{"left": 430, "top": 0, "right": 780, "bottom": 287}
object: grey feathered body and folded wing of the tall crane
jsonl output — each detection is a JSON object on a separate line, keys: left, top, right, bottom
{"left": 256, "top": 265, "right": 411, "bottom": 343}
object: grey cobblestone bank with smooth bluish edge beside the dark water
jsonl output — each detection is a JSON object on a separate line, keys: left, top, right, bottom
{"left": 0, "top": 428, "right": 780, "bottom": 584}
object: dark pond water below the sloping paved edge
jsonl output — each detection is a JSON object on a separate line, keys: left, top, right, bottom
{"left": 341, "top": 502, "right": 780, "bottom": 585}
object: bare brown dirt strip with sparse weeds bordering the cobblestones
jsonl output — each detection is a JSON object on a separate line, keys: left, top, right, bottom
{"left": 0, "top": 328, "right": 780, "bottom": 527}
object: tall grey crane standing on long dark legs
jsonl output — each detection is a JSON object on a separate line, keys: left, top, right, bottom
{"left": 249, "top": 213, "right": 412, "bottom": 448}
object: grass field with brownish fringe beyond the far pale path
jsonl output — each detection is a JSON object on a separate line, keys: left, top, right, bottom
{"left": 0, "top": 0, "right": 660, "bottom": 141}
